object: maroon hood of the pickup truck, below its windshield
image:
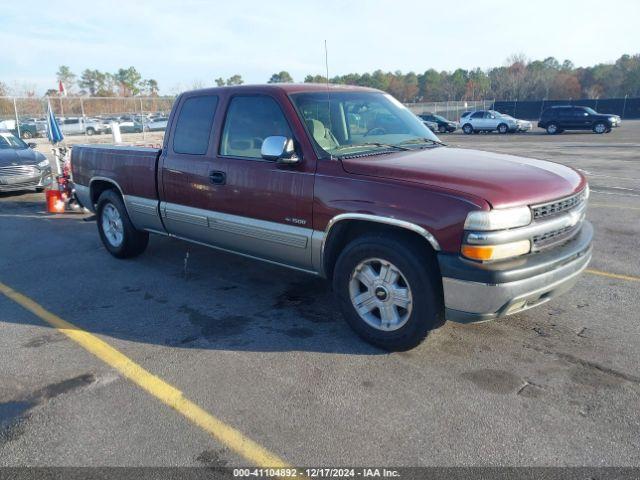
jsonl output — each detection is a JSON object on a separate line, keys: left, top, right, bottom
{"left": 342, "top": 147, "right": 586, "bottom": 208}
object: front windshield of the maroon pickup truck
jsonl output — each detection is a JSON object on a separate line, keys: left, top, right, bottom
{"left": 291, "top": 92, "right": 440, "bottom": 157}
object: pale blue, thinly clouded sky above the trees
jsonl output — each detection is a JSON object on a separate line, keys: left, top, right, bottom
{"left": 0, "top": 0, "right": 640, "bottom": 94}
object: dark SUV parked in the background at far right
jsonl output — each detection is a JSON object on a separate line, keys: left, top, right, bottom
{"left": 538, "top": 106, "right": 620, "bottom": 135}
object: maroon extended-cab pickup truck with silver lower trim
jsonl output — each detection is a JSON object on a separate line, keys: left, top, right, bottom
{"left": 72, "top": 84, "right": 593, "bottom": 350}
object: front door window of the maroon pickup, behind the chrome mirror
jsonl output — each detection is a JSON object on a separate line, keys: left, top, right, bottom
{"left": 220, "top": 95, "right": 292, "bottom": 158}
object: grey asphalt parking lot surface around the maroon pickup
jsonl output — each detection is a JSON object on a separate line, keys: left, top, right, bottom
{"left": 0, "top": 121, "right": 640, "bottom": 466}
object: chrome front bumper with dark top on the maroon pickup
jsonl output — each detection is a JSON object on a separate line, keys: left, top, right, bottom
{"left": 440, "top": 222, "right": 593, "bottom": 323}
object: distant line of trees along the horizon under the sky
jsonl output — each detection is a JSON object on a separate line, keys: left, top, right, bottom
{"left": 0, "top": 54, "right": 640, "bottom": 103}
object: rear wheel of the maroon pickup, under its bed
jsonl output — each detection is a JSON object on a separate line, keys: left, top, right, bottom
{"left": 96, "top": 190, "right": 149, "bottom": 258}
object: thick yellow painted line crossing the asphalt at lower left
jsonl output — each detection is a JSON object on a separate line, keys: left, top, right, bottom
{"left": 0, "top": 282, "right": 288, "bottom": 468}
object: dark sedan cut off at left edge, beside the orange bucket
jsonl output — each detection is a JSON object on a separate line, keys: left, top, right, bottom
{"left": 0, "top": 131, "right": 51, "bottom": 192}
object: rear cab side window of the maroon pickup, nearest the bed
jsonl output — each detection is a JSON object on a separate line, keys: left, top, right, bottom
{"left": 173, "top": 95, "right": 218, "bottom": 155}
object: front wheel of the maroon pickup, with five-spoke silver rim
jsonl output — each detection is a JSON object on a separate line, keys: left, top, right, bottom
{"left": 333, "top": 234, "right": 444, "bottom": 351}
